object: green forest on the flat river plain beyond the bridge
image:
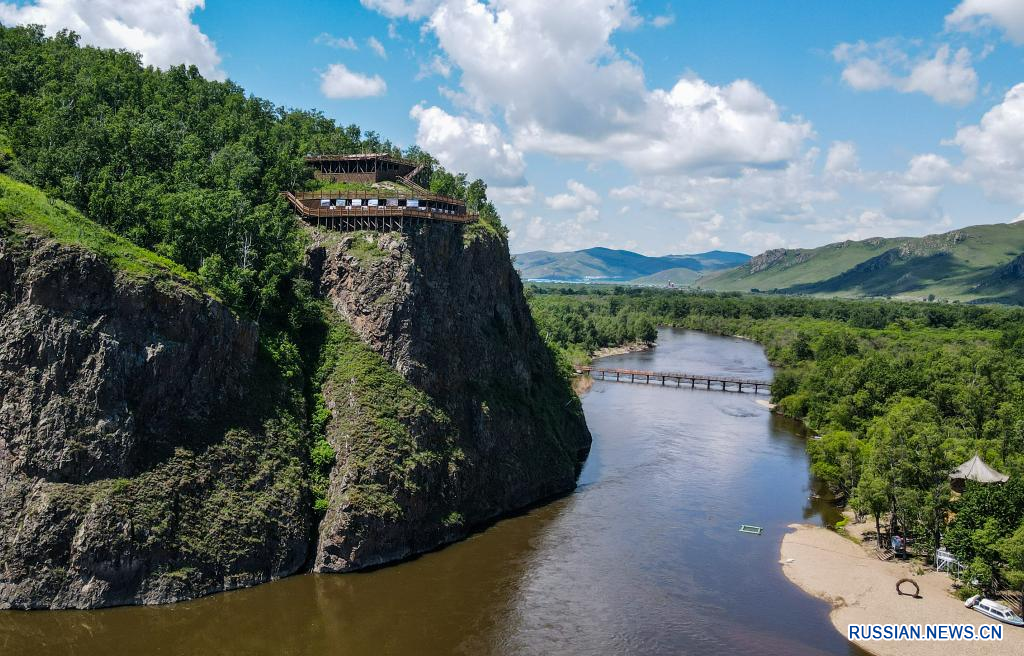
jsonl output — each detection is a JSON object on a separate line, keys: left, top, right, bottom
{"left": 527, "top": 286, "right": 1024, "bottom": 596}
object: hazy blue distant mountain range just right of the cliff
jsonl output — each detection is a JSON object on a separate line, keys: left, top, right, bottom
{"left": 515, "top": 248, "right": 751, "bottom": 286}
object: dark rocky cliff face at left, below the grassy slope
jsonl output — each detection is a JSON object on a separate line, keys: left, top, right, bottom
{"left": 0, "top": 233, "right": 309, "bottom": 608}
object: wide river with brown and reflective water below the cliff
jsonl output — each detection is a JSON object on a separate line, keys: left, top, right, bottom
{"left": 0, "top": 330, "right": 861, "bottom": 656}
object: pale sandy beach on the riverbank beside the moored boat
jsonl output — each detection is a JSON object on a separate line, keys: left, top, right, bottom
{"left": 780, "top": 524, "right": 1024, "bottom": 656}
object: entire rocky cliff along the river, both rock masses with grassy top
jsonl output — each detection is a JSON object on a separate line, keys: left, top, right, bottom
{"left": 0, "top": 183, "right": 590, "bottom": 608}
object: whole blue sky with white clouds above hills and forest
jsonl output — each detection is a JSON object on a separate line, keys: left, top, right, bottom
{"left": 0, "top": 0, "right": 1024, "bottom": 254}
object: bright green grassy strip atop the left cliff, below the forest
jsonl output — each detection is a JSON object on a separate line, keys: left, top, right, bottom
{"left": 0, "top": 174, "right": 209, "bottom": 293}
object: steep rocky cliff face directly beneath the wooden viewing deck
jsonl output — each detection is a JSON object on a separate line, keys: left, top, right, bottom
{"left": 308, "top": 225, "right": 591, "bottom": 571}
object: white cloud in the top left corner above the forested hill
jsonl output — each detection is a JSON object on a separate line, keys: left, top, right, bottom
{"left": 0, "top": 0, "right": 226, "bottom": 80}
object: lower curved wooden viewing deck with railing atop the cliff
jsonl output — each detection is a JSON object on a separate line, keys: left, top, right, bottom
{"left": 282, "top": 191, "right": 479, "bottom": 232}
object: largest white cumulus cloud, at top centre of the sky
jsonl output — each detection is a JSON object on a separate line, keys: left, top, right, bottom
{"left": 411, "top": 0, "right": 811, "bottom": 174}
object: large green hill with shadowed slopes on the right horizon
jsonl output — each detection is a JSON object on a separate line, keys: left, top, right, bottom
{"left": 697, "top": 222, "right": 1024, "bottom": 302}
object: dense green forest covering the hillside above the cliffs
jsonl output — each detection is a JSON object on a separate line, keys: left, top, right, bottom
{"left": 0, "top": 26, "right": 504, "bottom": 325}
